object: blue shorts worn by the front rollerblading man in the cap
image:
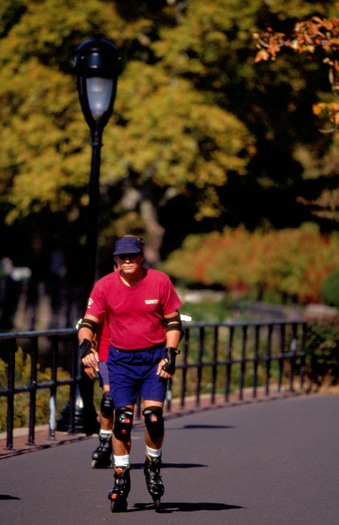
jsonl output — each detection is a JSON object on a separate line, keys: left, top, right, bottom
{"left": 107, "top": 345, "right": 167, "bottom": 408}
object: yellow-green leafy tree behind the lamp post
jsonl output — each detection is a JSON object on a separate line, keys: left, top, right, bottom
{"left": 0, "top": 0, "right": 254, "bottom": 264}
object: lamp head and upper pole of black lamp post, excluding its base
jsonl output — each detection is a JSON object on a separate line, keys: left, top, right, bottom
{"left": 74, "top": 38, "right": 121, "bottom": 304}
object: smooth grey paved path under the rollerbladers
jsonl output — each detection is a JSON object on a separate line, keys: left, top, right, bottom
{"left": 0, "top": 395, "right": 339, "bottom": 525}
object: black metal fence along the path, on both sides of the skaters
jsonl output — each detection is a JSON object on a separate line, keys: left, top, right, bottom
{"left": 0, "top": 320, "right": 307, "bottom": 449}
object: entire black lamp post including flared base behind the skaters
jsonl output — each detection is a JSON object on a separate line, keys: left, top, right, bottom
{"left": 63, "top": 38, "right": 121, "bottom": 434}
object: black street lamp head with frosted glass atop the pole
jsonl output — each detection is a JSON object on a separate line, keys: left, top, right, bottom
{"left": 74, "top": 38, "right": 121, "bottom": 131}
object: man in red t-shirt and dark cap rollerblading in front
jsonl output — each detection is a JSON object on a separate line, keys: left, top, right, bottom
{"left": 78, "top": 235, "right": 182, "bottom": 512}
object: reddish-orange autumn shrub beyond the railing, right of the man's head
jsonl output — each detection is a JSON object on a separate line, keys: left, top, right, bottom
{"left": 163, "top": 225, "right": 339, "bottom": 304}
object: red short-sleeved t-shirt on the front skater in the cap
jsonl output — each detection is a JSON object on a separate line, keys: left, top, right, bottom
{"left": 86, "top": 269, "right": 182, "bottom": 350}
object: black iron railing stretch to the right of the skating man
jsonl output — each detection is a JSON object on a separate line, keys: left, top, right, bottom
{"left": 171, "top": 320, "right": 307, "bottom": 410}
